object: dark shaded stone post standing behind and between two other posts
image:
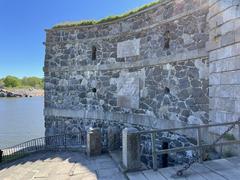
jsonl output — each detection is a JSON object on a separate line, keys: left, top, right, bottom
{"left": 108, "top": 126, "right": 121, "bottom": 151}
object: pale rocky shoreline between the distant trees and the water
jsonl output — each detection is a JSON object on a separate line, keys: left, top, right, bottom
{"left": 0, "top": 88, "right": 44, "bottom": 98}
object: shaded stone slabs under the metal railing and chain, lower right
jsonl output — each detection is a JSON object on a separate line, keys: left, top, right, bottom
{"left": 127, "top": 157, "right": 240, "bottom": 180}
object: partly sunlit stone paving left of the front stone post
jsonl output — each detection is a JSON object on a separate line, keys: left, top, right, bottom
{"left": 0, "top": 152, "right": 126, "bottom": 180}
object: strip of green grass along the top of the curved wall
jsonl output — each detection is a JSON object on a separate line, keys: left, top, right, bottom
{"left": 53, "top": 0, "right": 162, "bottom": 29}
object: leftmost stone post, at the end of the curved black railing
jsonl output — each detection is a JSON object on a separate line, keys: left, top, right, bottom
{"left": 87, "top": 128, "right": 102, "bottom": 156}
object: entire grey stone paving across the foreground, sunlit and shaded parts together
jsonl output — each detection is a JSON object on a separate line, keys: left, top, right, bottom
{"left": 0, "top": 152, "right": 240, "bottom": 180}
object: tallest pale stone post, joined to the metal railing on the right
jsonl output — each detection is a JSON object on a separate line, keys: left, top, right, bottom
{"left": 122, "top": 128, "right": 141, "bottom": 171}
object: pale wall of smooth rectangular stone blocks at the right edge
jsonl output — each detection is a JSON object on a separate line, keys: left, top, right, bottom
{"left": 207, "top": 0, "right": 240, "bottom": 133}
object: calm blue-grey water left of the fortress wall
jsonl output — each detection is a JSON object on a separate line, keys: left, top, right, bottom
{"left": 0, "top": 97, "right": 44, "bottom": 149}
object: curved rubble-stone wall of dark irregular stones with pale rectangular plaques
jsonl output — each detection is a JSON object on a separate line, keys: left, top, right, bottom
{"left": 44, "top": 0, "right": 209, "bottom": 135}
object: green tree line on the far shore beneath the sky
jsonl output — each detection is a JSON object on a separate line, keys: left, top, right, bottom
{"left": 0, "top": 76, "right": 43, "bottom": 89}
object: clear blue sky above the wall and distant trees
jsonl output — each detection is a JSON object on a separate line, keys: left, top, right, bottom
{"left": 0, "top": 0, "right": 154, "bottom": 78}
